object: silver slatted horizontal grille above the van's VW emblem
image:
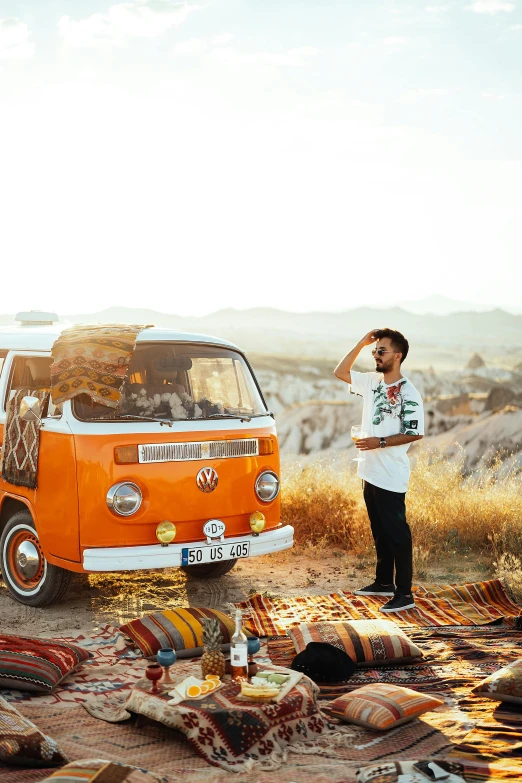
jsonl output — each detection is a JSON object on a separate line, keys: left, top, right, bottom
{"left": 138, "top": 438, "right": 259, "bottom": 462}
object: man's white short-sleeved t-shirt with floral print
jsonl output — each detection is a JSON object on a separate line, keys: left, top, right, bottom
{"left": 350, "top": 370, "right": 424, "bottom": 492}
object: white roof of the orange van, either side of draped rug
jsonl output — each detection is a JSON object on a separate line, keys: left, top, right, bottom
{"left": 0, "top": 324, "right": 239, "bottom": 351}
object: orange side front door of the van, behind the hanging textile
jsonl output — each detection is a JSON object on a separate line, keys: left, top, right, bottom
{"left": 0, "top": 351, "right": 80, "bottom": 565}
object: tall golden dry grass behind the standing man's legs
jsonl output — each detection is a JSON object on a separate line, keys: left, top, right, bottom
{"left": 282, "top": 449, "right": 522, "bottom": 591}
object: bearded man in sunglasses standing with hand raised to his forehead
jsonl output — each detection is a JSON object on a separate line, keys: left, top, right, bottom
{"left": 334, "top": 329, "right": 424, "bottom": 612}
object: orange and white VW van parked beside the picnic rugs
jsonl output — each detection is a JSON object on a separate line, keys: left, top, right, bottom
{"left": 0, "top": 311, "right": 294, "bottom": 606}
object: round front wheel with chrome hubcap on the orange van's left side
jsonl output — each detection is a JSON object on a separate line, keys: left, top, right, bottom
{"left": 0, "top": 511, "right": 71, "bottom": 606}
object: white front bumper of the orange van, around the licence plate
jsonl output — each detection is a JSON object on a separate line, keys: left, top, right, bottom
{"left": 83, "top": 525, "right": 294, "bottom": 571}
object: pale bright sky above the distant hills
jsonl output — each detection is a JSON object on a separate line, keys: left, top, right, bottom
{"left": 0, "top": 0, "right": 522, "bottom": 315}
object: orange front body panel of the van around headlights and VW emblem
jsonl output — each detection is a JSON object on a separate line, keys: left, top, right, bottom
{"left": 73, "top": 427, "right": 280, "bottom": 554}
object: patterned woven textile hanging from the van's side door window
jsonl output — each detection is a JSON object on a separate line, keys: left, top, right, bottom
{"left": 2, "top": 389, "right": 49, "bottom": 489}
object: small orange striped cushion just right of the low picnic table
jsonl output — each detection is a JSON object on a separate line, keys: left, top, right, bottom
{"left": 326, "top": 683, "right": 444, "bottom": 730}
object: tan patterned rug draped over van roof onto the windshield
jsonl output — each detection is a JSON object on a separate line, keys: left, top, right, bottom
{"left": 51, "top": 324, "right": 147, "bottom": 408}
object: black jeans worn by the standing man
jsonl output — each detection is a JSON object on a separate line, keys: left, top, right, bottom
{"left": 364, "top": 481, "right": 413, "bottom": 595}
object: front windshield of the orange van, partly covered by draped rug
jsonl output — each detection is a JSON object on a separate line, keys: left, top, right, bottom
{"left": 73, "top": 342, "right": 267, "bottom": 421}
